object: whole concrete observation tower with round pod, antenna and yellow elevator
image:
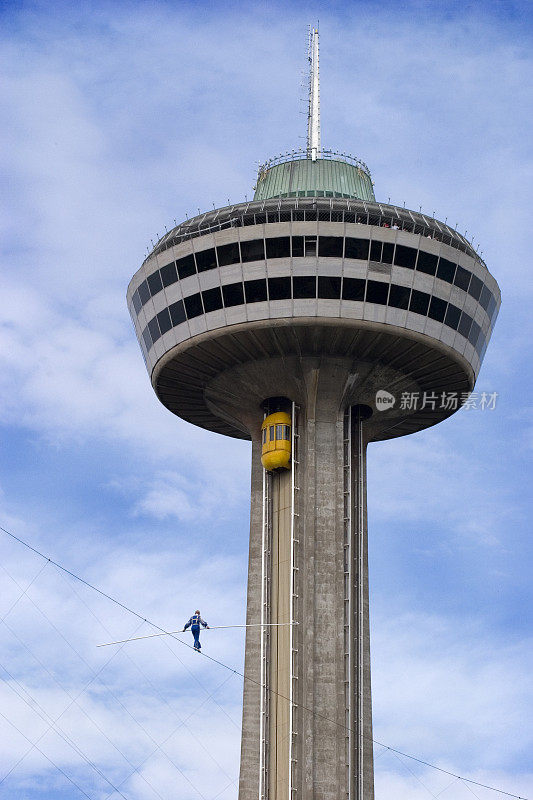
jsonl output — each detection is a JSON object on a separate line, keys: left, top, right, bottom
{"left": 127, "top": 29, "right": 500, "bottom": 800}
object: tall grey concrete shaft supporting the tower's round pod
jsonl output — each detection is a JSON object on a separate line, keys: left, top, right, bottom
{"left": 239, "top": 366, "right": 374, "bottom": 800}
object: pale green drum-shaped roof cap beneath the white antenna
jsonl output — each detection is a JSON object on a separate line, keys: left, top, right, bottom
{"left": 254, "top": 150, "right": 375, "bottom": 202}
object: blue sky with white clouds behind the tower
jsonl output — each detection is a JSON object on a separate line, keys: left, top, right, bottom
{"left": 0, "top": 0, "right": 533, "bottom": 800}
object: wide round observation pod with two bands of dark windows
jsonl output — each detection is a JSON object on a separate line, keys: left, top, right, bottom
{"left": 128, "top": 197, "right": 500, "bottom": 440}
